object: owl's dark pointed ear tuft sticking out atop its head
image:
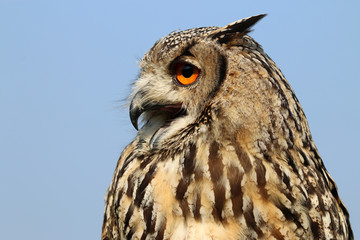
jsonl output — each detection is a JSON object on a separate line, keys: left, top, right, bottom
{"left": 208, "top": 14, "right": 266, "bottom": 43}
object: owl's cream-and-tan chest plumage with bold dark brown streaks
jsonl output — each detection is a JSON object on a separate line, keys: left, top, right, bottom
{"left": 115, "top": 144, "right": 320, "bottom": 239}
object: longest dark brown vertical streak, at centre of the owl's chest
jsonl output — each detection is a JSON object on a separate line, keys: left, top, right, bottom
{"left": 209, "top": 141, "right": 225, "bottom": 221}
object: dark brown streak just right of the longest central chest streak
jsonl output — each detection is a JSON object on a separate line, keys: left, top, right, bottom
{"left": 227, "top": 165, "right": 244, "bottom": 217}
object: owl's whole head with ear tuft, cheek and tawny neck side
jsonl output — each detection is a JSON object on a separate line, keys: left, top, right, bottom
{"left": 130, "top": 15, "right": 302, "bottom": 149}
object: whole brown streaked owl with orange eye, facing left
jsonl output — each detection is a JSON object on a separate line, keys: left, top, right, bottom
{"left": 102, "top": 15, "right": 353, "bottom": 240}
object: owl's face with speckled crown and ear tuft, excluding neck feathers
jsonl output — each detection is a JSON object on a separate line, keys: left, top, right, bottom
{"left": 130, "top": 15, "right": 264, "bottom": 148}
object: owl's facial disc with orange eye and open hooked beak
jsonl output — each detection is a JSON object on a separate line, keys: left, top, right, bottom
{"left": 130, "top": 30, "right": 226, "bottom": 146}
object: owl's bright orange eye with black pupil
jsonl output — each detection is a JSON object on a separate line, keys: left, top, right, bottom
{"left": 174, "top": 62, "right": 200, "bottom": 85}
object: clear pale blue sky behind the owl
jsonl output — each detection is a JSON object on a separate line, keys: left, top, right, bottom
{"left": 0, "top": 0, "right": 360, "bottom": 240}
